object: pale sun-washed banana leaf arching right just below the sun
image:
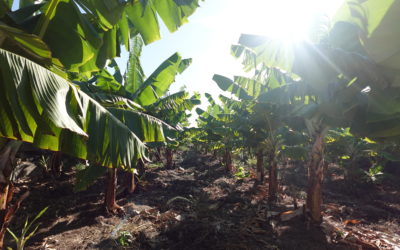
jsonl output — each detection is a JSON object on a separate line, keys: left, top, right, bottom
{"left": 239, "top": 35, "right": 388, "bottom": 91}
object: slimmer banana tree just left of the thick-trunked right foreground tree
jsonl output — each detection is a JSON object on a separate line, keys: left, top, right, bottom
{"left": 213, "top": 53, "right": 296, "bottom": 202}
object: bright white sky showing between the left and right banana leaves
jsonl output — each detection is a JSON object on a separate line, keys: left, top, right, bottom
{"left": 121, "top": 0, "right": 343, "bottom": 101}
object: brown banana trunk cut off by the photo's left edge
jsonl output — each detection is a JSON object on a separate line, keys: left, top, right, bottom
{"left": 0, "top": 140, "right": 23, "bottom": 249}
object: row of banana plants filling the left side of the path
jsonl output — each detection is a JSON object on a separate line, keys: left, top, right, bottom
{"left": 0, "top": 0, "right": 199, "bottom": 248}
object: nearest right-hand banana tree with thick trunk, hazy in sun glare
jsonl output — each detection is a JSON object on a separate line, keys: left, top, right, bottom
{"left": 234, "top": 0, "right": 399, "bottom": 222}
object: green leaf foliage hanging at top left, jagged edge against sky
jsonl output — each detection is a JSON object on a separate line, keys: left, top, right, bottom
{"left": 3, "top": 0, "right": 199, "bottom": 74}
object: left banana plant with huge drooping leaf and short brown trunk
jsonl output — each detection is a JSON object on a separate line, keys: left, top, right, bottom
{"left": 0, "top": 15, "right": 194, "bottom": 215}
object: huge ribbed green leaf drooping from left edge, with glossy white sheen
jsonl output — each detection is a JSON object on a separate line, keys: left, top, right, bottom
{"left": 0, "top": 49, "right": 166, "bottom": 168}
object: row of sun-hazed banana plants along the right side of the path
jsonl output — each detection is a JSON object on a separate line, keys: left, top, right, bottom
{"left": 198, "top": 0, "right": 400, "bottom": 223}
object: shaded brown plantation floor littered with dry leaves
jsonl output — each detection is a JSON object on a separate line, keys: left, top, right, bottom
{"left": 6, "top": 151, "right": 400, "bottom": 249}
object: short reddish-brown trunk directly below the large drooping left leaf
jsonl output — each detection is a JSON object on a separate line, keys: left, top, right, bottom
{"left": 104, "top": 168, "right": 123, "bottom": 214}
